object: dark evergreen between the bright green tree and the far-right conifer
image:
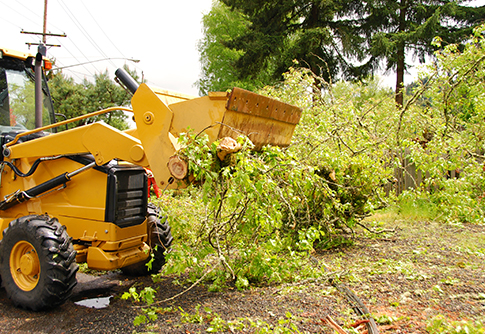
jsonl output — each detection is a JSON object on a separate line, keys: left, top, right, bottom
{"left": 222, "top": 0, "right": 366, "bottom": 89}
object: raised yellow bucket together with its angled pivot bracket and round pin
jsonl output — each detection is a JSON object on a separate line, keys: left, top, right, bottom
{"left": 130, "top": 84, "right": 301, "bottom": 188}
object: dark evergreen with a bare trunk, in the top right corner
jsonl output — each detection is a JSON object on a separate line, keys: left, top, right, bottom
{"left": 351, "top": 0, "right": 485, "bottom": 105}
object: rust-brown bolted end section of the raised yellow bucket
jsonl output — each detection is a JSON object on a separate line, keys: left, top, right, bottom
{"left": 218, "top": 88, "right": 301, "bottom": 150}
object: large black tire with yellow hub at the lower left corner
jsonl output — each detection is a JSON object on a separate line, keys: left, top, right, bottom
{"left": 0, "top": 215, "right": 78, "bottom": 311}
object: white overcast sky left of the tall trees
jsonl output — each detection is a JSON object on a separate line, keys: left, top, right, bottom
{"left": 0, "top": 0, "right": 212, "bottom": 95}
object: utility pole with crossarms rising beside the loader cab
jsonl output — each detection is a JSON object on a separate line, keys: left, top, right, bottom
{"left": 20, "top": 0, "right": 66, "bottom": 128}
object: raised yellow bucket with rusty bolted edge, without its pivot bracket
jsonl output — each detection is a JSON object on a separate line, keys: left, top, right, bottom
{"left": 166, "top": 88, "right": 301, "bottom": 150}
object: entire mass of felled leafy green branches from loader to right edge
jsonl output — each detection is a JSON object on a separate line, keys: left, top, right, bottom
{"left": 153, "top": 24, "right": 485, "bottom": 289}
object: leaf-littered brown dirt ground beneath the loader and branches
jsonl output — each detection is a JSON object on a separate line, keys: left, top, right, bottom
{"left": 0, "top": 217, "right": 485, "bottom": 333}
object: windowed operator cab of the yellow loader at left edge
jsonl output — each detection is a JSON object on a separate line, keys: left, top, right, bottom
{"left": 0, "top": 48, "right": 55, "bottom": 133}
